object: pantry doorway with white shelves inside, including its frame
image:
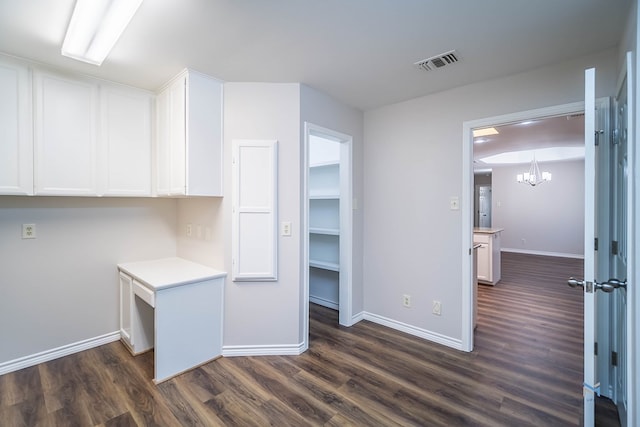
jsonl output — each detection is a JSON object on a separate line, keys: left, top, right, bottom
{"left": 303, "top": 123, "right": 353, "bottom": 346}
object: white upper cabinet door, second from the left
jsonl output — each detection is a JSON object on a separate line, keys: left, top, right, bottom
{"left": 34, "top": 72, "right": 98, "bottom": 196}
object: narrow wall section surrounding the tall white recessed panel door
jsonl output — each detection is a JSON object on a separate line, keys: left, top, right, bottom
{"left": 218, "top": 83, "right": 301, "bottom": 353}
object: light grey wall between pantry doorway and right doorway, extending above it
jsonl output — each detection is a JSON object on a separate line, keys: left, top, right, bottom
{"left": 363, "top": 49, "right": 618, "bottom": 341}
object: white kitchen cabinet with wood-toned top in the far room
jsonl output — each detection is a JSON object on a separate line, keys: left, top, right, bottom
{"left": 473, "top": 228, "right": 502, "bottom": 285}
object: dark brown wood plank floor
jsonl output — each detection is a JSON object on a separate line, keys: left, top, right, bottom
{"left": 0, "top": 254, "right": 616, "bottom": 427}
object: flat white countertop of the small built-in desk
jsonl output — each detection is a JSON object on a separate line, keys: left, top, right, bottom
{"left": 118, "top": 257, "right": 227, "bottom": 291}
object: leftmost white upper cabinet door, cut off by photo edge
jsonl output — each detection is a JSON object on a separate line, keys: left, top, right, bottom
{"left": 0, "top": 59, "right": 33, "bottom": 195}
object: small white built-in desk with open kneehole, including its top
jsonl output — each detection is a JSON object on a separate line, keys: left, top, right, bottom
{"left": 118, "top": 258, "right": 226, "bottom": 383}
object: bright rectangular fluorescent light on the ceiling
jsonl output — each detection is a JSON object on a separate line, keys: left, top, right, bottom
{"left": 62, "top": 0, "right": 142, "bottom": 65}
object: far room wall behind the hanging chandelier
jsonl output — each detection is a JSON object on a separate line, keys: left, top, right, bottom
{"left": 492, "top": 160, "right": 584, "bottom": 258}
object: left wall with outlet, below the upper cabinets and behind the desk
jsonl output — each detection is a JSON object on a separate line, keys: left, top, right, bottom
{"left": 0, "top": 196, "right": 176, "bottom": 364}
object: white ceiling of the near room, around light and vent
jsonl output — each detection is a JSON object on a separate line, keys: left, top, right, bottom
{"left": 0, "top": 0, "right": 631, "bottom": 110}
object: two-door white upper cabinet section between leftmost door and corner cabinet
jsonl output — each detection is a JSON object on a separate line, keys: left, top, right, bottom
{"left": 34, "top": 70, "right": 153, "bottom": 197}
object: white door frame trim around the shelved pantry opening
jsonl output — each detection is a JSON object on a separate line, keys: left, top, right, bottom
{"left": 302, "top": 122, "right": 355, "bottom": 351}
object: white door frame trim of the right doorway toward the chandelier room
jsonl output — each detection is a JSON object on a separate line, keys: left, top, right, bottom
{"left": 461, "top": 101, "right": 584, "bottom": 351}
